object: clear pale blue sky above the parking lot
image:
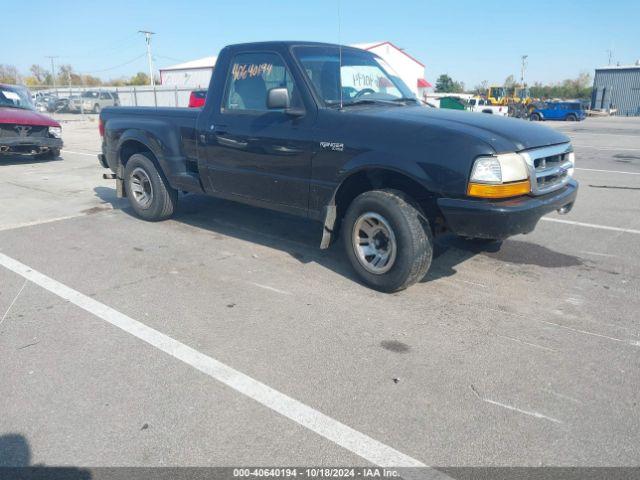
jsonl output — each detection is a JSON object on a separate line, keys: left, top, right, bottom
{"left": 0, "top": 0, "right": 640, "bottom": 88}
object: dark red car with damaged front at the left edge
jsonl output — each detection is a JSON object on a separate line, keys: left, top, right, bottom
{"left": 0, "top": 83, "right": 62, "bottom": 157}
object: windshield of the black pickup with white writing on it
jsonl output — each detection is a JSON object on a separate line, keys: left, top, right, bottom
{"left": 294, "top": 46, "right": 415, "bottom": 106}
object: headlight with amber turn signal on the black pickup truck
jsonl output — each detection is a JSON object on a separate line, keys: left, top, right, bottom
{"left": 467, "top": 153, "right": 531, "bottom": 198}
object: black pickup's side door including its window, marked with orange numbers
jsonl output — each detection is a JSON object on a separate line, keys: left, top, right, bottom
{"left": 199, "top": 52, "right": 313, "bottom": 212}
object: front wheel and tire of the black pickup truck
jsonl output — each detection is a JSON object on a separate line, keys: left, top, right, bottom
{"left": 342, "top": 190, "right": 433, "bottom": 293}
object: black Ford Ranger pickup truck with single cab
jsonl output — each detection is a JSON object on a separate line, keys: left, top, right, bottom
{"left": 99, "top": 42, "right": 578, "bottom": 292}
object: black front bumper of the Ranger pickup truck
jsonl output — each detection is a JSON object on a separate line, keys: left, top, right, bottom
{"left": 438, "top": 179, "right": 578, "bottom": 239}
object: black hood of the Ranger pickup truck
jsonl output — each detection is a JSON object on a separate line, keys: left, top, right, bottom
{"left": 349, "top": 105, "right": 570, "bottom": 153}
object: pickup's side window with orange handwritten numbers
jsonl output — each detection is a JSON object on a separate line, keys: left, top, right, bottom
{"left": 222, "top": 52, "right": 302, "bottom": 112}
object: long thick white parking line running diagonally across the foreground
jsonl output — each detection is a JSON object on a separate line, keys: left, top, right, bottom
{"left": 0, "top": 253, "right": 450, "bottom": 479}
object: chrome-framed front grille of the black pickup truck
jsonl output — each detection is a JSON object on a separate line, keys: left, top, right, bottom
{"left": 521, "top": 143, "right": 574, "bottom": 195}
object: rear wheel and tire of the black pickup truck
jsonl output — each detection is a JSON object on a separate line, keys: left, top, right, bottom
{"left": 124, "top": 153, "right": 178, "bottom": 222}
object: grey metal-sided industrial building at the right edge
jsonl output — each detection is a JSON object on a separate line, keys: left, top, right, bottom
{"left": 591, "top": 61, "right": 640, "bottom": 117}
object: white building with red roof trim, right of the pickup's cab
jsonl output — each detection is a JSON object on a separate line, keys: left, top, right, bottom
{"left": 351, "top": 42, "right": 431, "bottom": 98}
